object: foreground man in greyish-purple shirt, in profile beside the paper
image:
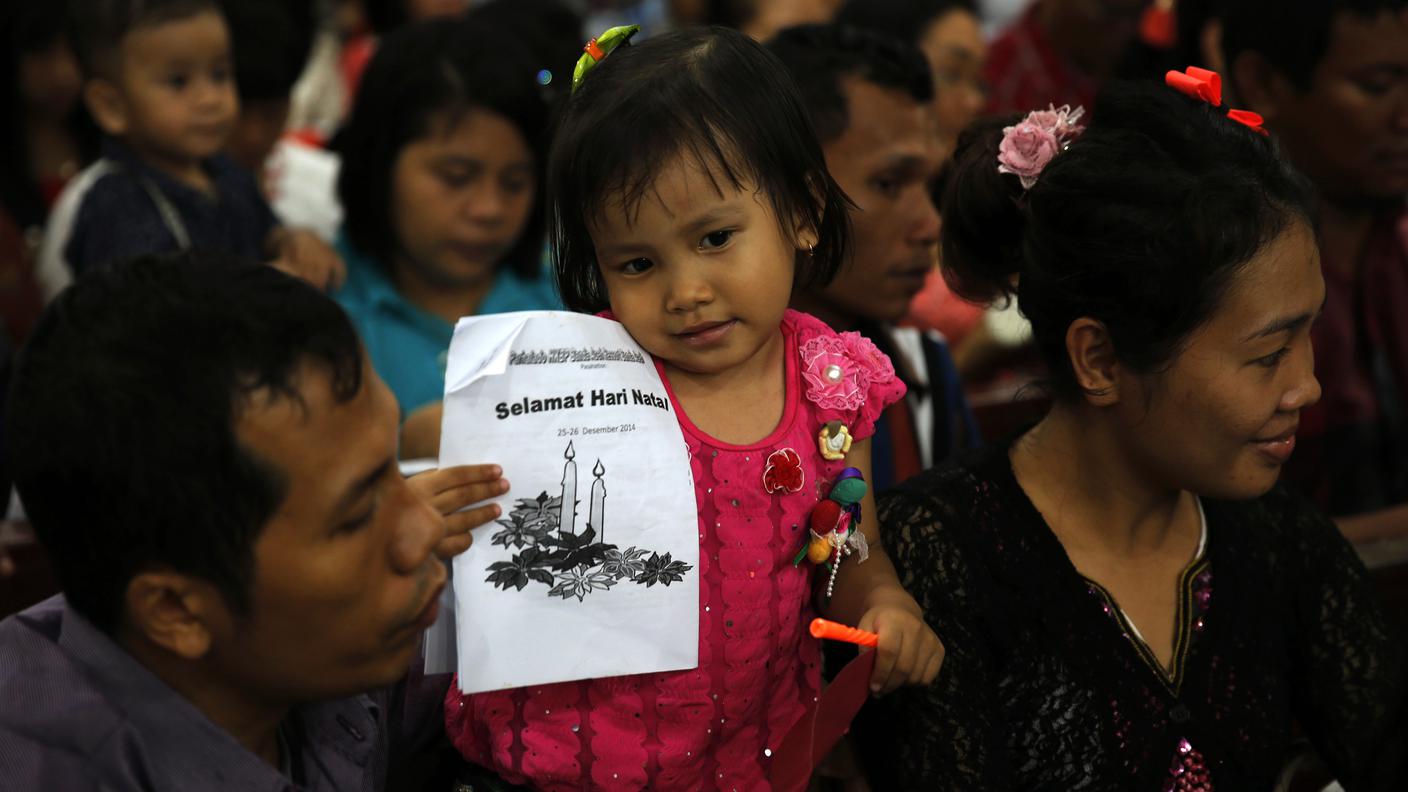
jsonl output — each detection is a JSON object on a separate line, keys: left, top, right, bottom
{"left": 0, "top": 255, "right": 508, "bottom": 791}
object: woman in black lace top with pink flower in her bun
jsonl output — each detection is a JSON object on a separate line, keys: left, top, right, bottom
{"left": 856, "top": 80, "right": 1408, "bottom": 792}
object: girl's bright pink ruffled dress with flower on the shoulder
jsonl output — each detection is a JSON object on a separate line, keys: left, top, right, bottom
{"left": 445, "top": 310, "right": 904, "bottom": 792}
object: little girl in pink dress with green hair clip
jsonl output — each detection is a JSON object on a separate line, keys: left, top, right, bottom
{"left": 446, "top": 30, "right": 943, "bottom": 791}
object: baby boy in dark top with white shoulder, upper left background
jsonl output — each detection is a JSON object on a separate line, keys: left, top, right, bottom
{"left": 39, "top": 0, "right": 344, "bottom": 293}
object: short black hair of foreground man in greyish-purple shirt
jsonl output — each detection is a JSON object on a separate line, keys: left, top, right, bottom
{"left": 4, "top": 254, "right": 362, "bottom": 633}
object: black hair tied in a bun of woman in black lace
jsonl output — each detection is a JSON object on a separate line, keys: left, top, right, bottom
{"left": 942, "top": 83, "right": 1312, "bottom": 397}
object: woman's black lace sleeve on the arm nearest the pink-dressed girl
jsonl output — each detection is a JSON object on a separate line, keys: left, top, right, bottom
{"left": 860, "top": 489, "right": 1012, "bottom": 791}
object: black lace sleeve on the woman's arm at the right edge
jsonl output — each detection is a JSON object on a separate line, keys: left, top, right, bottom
{"left": 1284, "top": 500, "right": 1408, "bottom": 792}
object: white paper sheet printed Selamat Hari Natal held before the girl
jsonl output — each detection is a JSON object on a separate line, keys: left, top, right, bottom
{"left": 439, "top": 311, "right": 700, "bottom": 693}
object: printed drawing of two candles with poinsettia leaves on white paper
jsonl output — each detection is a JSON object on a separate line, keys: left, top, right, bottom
{"left": 484, "top": 443, "right": 694, "bottom": 602}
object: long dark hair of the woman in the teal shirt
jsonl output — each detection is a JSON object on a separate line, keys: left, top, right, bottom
{"left": 332, "top": 18, "right": 548, "bottom": 278}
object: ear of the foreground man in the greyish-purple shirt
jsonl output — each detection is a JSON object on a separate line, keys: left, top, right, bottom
{"left": 125, "top": 571, "right": 227, "bottom": 661}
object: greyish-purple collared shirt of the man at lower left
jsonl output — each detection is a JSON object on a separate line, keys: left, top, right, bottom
{"left": 0, "top": 595, "right": 449, "bottom": 792}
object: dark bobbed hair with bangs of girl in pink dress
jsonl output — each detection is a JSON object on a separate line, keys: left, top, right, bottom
{"left": 548, "top": 27, "right": 850, "bottom": 311}
